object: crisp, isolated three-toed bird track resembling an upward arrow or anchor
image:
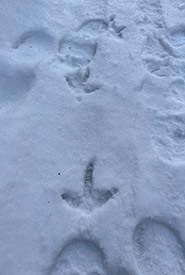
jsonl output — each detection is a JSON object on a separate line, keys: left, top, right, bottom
{"left": 61, "top": 160, "right": 118, "bottom": 211}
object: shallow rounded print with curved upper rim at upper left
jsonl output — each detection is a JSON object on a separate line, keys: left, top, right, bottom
{"left": 12, "top": 30, "right": 54, "bottom": 61}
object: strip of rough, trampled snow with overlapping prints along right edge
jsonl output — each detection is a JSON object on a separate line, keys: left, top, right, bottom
{"left": 138, "top": 0, "right": 185, "bottom": 164}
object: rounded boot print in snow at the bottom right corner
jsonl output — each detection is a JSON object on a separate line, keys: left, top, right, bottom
{"left": 133, "top": 218, "right": 185, "bottom": 275}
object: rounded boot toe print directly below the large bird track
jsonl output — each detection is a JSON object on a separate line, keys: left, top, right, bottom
{"left": 49, "top": 239, "right": 107, "bottom": 275}
